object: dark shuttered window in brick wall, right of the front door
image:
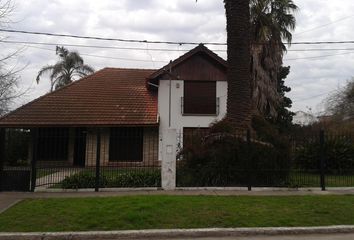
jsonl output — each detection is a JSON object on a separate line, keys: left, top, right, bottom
{"left": 109, "top": 128, "right": 144, "bottom": 162}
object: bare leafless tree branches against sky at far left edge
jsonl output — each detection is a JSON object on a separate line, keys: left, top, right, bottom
{"left": 0, "top": 0, "right": 23, "bottom": 116}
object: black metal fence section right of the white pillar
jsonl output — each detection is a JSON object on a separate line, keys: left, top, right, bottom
{"left": 177, "top": 130, "right": 354, "bottom": 190}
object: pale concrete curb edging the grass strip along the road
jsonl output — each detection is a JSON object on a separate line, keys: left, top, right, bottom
{"left": 0, "top": 226, "right": 354, "bottom": 240}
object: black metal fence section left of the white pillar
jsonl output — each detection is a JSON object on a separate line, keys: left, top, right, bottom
{"left": 0, "top": 127, "right": 161, "bottom": 191}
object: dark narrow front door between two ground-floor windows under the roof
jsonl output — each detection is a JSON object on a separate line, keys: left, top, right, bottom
{"left": 74, "top": 128, "right": 87, "bottom": 167}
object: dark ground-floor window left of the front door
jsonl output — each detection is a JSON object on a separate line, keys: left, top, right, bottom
{"left": 38, "top": 128, "right": 69, "bottom": 161}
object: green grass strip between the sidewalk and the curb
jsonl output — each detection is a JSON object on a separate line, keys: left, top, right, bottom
{"left": 0, "top": 196, "right": 354, "bottom": 232}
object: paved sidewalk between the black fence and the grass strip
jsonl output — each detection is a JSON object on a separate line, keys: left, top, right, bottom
{"left": 0, "top": 188, "right": 354, "bottom": 213}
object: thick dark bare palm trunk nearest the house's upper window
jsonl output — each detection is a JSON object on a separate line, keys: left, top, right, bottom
{"left": 224, "top": 0, "right": 252, "bottom": 129}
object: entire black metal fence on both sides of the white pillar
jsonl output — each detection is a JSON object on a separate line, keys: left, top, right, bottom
{"left": 0, "top": 127, "right": 354, "bottom": 191}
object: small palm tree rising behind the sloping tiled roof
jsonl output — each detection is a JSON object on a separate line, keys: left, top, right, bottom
{"left": 36, "top": 47, "right": 95, "bottom": 92}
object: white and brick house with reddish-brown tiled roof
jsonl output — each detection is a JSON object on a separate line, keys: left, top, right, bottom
{"left": 0, "top": 45, "right": 227, "bottom": 167}
